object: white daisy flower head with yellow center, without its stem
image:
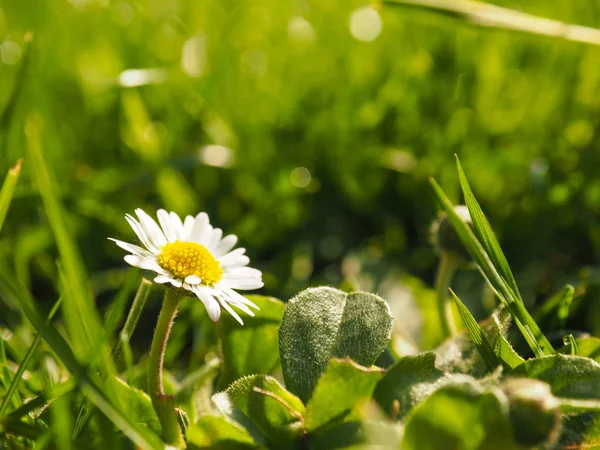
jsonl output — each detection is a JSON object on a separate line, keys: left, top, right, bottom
{"left": 109, "top": 209, "right": 263, "bottom": 325}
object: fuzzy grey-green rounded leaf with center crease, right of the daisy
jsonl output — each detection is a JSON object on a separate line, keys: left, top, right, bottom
{"left": 279, "top": 287, "right": 392, "bottom": 402}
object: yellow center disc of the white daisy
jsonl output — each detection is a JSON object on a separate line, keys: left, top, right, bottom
{"left": 158, "top": 241, "right": 223, "bottom": 286}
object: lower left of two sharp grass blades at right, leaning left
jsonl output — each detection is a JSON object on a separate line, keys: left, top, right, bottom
{"left": 430, "top": 178, "right": 555, "bottom": 356}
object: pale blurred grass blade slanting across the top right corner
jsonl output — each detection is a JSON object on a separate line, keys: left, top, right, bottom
{"left": 384, "top": 0, "right": 600, "bottom": 45}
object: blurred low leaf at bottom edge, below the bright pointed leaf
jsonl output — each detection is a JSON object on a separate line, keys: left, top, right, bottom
{"left": 309, "top": 421, "right": 402, "bottom": 450}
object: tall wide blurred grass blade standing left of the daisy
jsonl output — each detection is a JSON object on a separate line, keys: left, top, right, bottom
{"left": 25, "top": 116, "right": 103, "bottom": 361}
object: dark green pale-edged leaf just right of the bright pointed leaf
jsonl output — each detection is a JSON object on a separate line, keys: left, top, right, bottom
{"left": 373, "top": 352, "right": 470, "bottom": 419}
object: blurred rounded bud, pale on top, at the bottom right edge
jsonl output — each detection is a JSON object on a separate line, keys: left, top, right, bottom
{"left": 502, "top": 378, "right": 561, "bottom": 447}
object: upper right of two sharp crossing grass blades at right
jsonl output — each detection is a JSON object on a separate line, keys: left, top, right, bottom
{"left": 454, "top": 155, "right": 523, "bottom": 303}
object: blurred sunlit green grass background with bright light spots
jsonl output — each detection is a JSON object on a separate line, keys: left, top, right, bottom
{"left": 0, "top": 0, "right": 600, "bottom": 350}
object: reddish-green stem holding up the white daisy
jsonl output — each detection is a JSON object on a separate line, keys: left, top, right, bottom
{"left": 148, "top": 289, "right": 185, "bottom": 448}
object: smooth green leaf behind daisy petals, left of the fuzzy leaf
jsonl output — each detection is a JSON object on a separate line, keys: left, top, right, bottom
{"left": 219, "top": 295, "right": 285, "bottom": 388}
